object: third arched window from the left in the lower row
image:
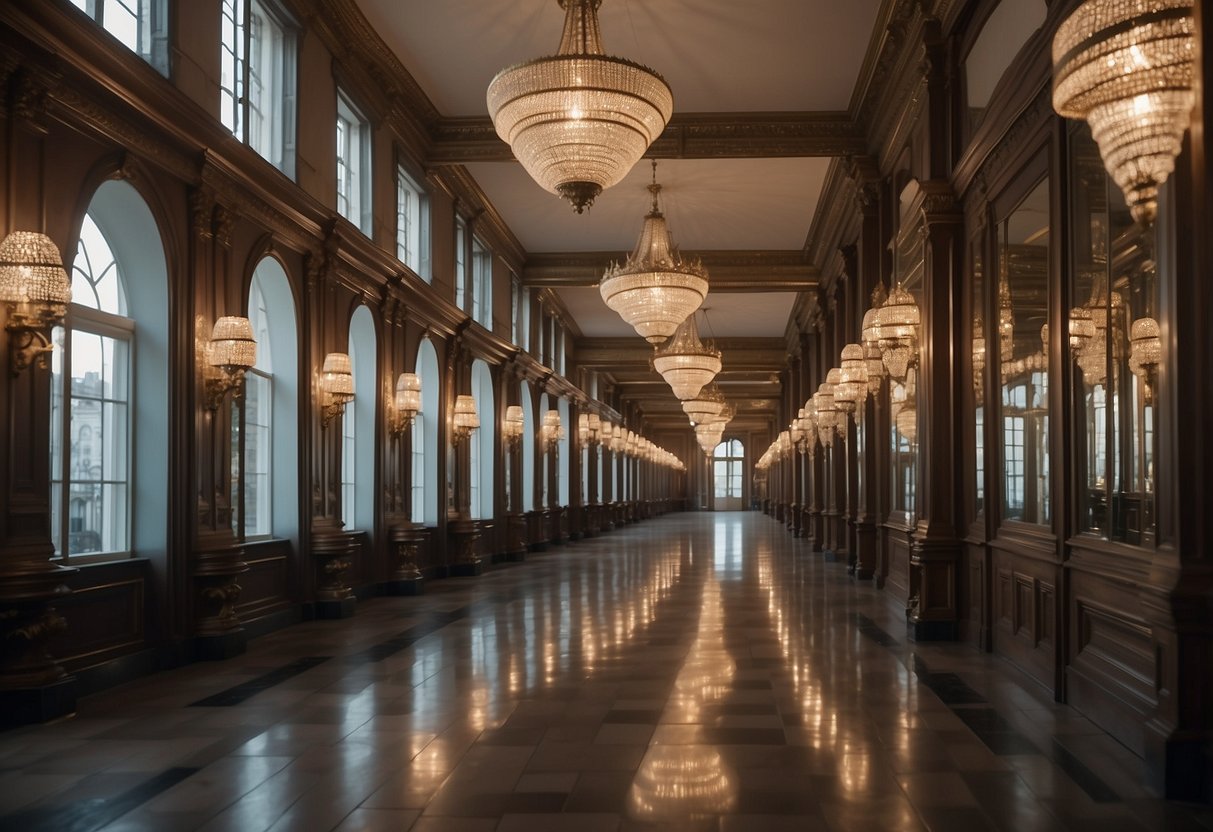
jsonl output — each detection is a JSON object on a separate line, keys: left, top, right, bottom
{"left": 341, "top": 306, "right": 377, "bottom": 531}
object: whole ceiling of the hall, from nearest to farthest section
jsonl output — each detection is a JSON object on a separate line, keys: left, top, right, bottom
{"left": 355, "top": 0, "right": 888, "bottom": 427}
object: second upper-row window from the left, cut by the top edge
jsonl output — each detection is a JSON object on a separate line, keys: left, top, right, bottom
{"left": 220, "top": 0, "right": 297, "bottom": 177}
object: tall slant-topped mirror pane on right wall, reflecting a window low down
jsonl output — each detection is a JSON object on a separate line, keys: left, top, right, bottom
{"left": 998, "top": 179, "right": 1049, "bottom": 525}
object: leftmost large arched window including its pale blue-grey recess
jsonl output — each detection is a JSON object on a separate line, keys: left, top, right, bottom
{"left": 50, "top": 182, "right": 169, "bottom": 558}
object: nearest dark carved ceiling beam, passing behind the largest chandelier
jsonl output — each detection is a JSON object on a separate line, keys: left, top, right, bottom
{"left": 428, "top": 112, "right": 867, "bottom": 165}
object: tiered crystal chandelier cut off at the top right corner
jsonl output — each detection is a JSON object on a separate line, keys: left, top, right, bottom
{"left": 1053, "top": 0, "right": 1196, "bottom": 226}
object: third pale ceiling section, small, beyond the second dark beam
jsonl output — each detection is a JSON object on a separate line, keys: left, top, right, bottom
{"left": 557, "top": 286, "right": 796, "bottom": 340}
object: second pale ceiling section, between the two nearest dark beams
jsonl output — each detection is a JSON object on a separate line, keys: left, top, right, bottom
{"left": 467, "top": 159, "right": 830, "bottom": 252}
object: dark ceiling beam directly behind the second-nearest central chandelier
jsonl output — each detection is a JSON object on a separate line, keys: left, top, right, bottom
{"left": 522, "top": 250, "right": 819, "bottom": 292}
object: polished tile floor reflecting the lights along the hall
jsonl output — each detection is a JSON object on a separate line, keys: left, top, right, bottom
{"left": 0, "top": 513, "right": 1213, "bottom": 832}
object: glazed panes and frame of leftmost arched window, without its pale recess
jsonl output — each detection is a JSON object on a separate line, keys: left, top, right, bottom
{"left": 51, "top": 215, "right": 135, "bottom": 557}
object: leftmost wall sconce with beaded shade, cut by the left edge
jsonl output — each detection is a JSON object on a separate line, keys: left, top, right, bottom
{"left": 0, "top": 232, "right": 72, "bottom": 376}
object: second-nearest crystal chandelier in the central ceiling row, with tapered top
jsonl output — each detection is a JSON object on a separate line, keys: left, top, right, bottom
{"left": 598, "top": 160, "right": 707, "bottom": 344}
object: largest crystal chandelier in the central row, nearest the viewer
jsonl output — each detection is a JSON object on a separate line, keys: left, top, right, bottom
{"left": 488, "top": 0, "right": 674, "bottom": 213}
